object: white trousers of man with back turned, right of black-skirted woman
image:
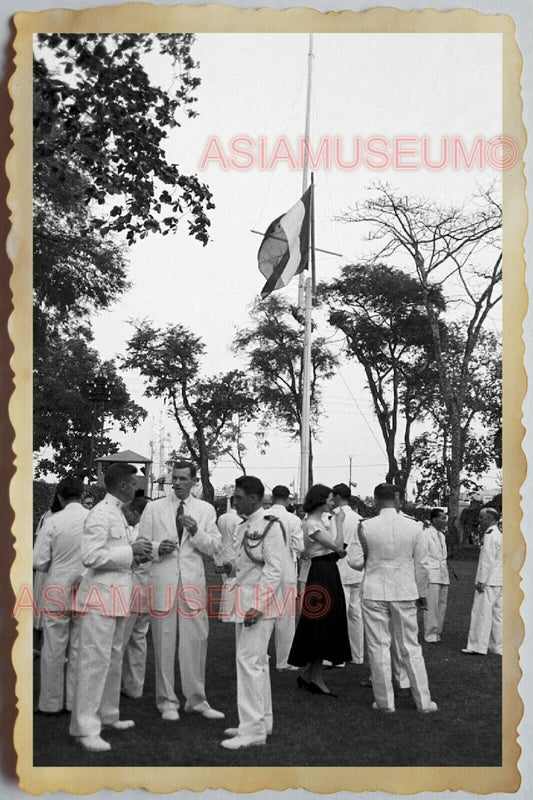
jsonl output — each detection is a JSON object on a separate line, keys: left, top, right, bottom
{"left": 363, "top": 600, "right": 431, "bottom": 711}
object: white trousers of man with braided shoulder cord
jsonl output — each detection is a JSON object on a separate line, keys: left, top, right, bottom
{"left": 235, "top": 618, "right": 274, "bottom": 738}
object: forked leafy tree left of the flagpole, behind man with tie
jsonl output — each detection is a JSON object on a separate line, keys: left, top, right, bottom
{"left": 122, "top": 321, "right": 257, "bottom": 501}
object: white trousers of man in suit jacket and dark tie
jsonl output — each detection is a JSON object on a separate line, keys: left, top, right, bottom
{"left": 150, "top": 605, "right": 209, "bottom": 713}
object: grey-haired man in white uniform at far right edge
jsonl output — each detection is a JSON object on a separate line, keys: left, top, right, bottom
{"left": 462, "top": 508, "right": 503, "bottom": 656}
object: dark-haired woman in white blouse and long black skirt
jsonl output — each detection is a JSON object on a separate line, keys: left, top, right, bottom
{"left": 288, "top": 483, "right": 352, "bottom": 697}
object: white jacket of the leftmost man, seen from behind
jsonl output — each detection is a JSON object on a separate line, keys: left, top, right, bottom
{"left": 33, "top": 503, "right": 89, "bottom": 613}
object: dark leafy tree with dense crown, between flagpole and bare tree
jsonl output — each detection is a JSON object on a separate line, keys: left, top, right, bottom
{"left": 319, "top": 264, "right": 444, "bottom": 490}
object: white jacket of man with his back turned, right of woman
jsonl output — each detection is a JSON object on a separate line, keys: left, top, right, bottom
{"left": 359, "top": 508, "right": 429, "bottom": 601}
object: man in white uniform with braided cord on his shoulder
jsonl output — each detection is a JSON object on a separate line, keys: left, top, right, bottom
{"left": 221, "top": 475, "right": 286, "bottom": 750}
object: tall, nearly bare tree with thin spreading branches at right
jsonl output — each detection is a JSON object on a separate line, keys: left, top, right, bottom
{"left": 342, "top": 185, "right": 502, "bottom": 520}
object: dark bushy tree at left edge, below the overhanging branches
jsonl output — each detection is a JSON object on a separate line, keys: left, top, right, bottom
{"left": 33, "top": 337, "right": 146, "bottom": 479}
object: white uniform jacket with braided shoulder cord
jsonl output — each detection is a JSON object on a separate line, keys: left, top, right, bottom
{"left": 234, "top": 508, "right": 287, "bottom": 622}
